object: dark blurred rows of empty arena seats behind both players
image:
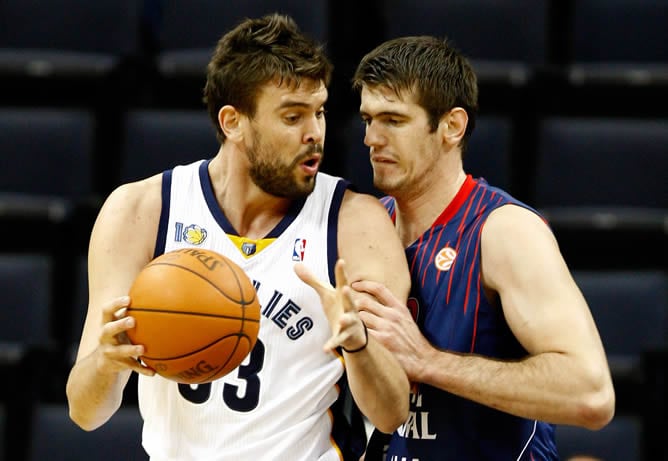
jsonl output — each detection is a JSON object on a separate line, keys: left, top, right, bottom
{"left": 0, "top": 0, "right": 668, "bottom": 461}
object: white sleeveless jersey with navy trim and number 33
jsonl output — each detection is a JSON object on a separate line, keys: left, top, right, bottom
{"left": 139, "top": 161, "right": 358, "bottom": 461}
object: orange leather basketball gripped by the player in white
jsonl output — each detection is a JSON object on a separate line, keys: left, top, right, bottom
{"left": 127, "top": 248, "right": 260, "bottom": 384}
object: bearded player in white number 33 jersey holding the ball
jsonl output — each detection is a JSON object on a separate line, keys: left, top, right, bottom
{"left": 67, "top": 14, "right": 410, "bottom": 461}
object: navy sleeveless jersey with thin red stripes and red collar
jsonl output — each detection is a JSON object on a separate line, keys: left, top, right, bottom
{"left": 369, "top": 176, "right": 558, "bottom": 461}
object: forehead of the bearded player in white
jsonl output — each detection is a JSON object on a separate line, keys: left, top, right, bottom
{"left": 257, "top": 79, "right": 328, "bottom": 111}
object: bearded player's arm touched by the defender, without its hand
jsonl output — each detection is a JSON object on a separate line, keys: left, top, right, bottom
{"left": 338, "top": 192, "right": 410, "bottom": 432}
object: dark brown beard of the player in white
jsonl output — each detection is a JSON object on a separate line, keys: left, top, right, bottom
{"left": 246, "top": 131, "right": 323, "bottom": 199}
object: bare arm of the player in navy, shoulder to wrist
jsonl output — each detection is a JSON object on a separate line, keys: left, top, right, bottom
{"left": 415, "top": 206, "right": 614, "bottom": 429}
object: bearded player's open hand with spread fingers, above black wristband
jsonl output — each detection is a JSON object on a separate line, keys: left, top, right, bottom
{"left": 294, "top": 259, "right": 367, "bottom": 351}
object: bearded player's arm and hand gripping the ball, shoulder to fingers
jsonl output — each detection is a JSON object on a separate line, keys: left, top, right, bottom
{"left": 66, "top": 177, "right": 161, "bottom": 430}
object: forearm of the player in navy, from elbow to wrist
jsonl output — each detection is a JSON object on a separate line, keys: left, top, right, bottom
{"left": 420, "top": 351, "right": 609, "bottom": 429}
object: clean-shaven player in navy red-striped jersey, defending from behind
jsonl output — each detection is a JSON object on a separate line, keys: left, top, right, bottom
{"left": 353, "top": 37, "right": 615, "bottom": 461}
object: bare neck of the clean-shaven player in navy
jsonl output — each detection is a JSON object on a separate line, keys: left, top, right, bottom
{"left": 395, "top": 170, "right": 466, "bottom": 247}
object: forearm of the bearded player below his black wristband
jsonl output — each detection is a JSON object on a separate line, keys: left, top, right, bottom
{"left": 344, "top": 336, "right": 410, "bottom": 433}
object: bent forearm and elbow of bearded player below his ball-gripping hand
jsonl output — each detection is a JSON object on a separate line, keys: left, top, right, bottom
{"left": 66, "top": 352, "right": 131, "bottom": 431}
